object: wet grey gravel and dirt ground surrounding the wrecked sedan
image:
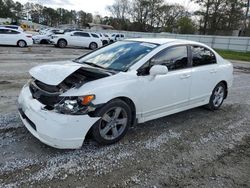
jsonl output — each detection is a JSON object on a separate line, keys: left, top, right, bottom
{"left": 0, "top": 46, "right": 250, "bottom": 188}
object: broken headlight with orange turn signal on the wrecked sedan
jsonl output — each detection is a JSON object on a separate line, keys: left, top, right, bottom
{"left": 54, "top": 95, "right": 95, "bottom": 115}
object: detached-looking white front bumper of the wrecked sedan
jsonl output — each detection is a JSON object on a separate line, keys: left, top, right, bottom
{"left": 18, "top": 85, "right": 99, "bottom": 149}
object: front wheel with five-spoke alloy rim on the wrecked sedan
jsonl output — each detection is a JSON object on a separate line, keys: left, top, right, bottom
{"left": 92, "top": 99, "right": 132, "bottom": 145}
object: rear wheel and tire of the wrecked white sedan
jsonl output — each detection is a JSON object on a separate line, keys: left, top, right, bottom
{"left": 207, "top": 82, "right": 226, "bottom": 110}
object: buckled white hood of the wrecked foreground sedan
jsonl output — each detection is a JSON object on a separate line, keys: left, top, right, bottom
{"left": 29, "top": 61, "right": 83, "bottom": 86}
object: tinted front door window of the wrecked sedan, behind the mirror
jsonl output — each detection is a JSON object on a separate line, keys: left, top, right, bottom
{"left": 151, "top": 46, "right": 188, "bottom": 71}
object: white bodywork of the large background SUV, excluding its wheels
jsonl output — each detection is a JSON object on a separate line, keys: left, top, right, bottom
{"left": 50, "top": 31, "right": 102, "bottom": 48}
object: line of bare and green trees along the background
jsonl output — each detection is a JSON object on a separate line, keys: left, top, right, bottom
{"left": 0, "top": 0, "right": 250, "bottom": 35}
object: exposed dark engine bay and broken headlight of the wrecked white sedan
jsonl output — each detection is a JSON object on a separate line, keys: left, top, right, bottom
{"left": 29, "top": 68, "right": 110, "bottom": 115}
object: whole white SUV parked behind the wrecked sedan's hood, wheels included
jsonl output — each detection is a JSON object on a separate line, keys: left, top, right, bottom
{"left": 51, "top": 31, "right": 102, "bottom": 50}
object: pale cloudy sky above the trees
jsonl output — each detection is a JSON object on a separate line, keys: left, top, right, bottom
{"left": 17, "top": 0, "right": 197, "bottom": 16}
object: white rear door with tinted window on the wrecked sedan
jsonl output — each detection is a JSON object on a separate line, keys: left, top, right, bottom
{"left": 190, "top": 45, "right": 219, "bottom": 103}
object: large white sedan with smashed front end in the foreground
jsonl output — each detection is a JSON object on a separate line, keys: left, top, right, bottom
{"left": 18, "top": 39, "right": 233, "bottom": 149}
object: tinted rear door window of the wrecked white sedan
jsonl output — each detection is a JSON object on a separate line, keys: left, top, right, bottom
{"left": 191, "top": 46, "right": 216, "bottom": 67}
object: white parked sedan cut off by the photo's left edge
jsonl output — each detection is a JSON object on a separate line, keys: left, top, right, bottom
{"left": 0, "top": 27, "right": 33, "bottom": 47}
